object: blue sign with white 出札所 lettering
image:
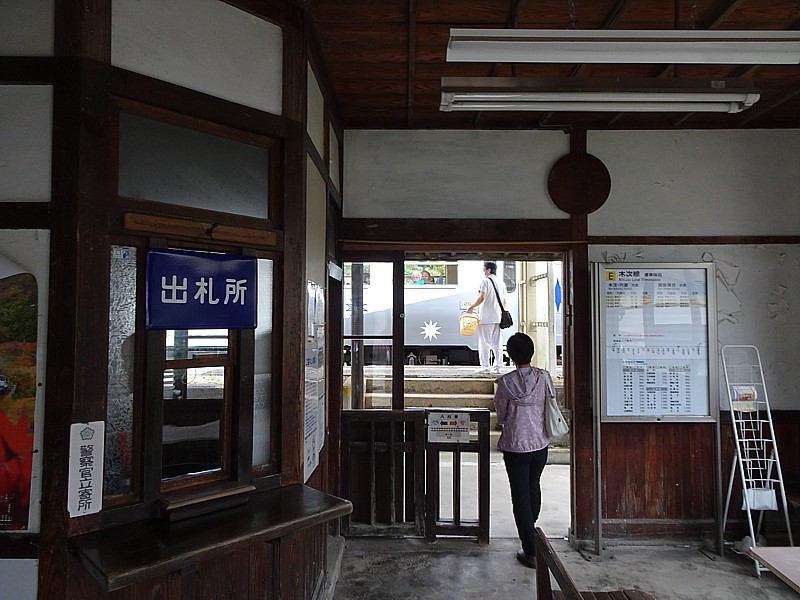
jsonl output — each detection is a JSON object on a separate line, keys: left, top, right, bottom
{"left": 147, "top": 250, "right": 258, "bottom": 329}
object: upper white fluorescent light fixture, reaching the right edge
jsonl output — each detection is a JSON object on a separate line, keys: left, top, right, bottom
{"left": 447, "top": 29, "right": 800, "bottom": 65}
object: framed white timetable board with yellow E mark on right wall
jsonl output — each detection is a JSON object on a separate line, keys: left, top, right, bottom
{"left": 594, "top": 263, "right": 717, "bottom": 421}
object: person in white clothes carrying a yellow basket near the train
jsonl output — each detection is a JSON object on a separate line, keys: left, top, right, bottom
{"left": 467, "top": 261, "right": 506, "bottom": 373}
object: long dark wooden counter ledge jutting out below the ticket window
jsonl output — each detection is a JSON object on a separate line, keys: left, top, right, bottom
{"left": 70, "top": 484, "right": 353, "bottom": 592}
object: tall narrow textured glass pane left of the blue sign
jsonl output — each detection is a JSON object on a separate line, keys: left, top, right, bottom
{"left": 103, "top": 246, "right": 136, "bottom": 496}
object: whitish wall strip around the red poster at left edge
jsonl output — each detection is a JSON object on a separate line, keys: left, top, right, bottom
{"left": 0, "top": 229, "right": 50, "bottom": 528}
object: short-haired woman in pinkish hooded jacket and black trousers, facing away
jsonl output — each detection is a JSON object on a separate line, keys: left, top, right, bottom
{"left": 494, "top": 333, "right": 555, "bottom": 569}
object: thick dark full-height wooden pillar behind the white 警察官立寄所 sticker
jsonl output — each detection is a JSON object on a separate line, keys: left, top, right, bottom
{"left": 39, "top": 0, "right": 111, "bottom": 599}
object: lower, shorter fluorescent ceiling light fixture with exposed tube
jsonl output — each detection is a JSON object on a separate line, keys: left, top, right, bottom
{"left": 439, "top": 77, "right": 759, "bottom": 113}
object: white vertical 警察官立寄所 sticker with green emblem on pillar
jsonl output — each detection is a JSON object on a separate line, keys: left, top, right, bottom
{"left": 67, "top": 421, "right": 106, "bottom": 517}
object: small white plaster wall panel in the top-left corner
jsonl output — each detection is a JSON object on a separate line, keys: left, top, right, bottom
{"left": 0, "top": 0, "right": 55, "bottom": 56}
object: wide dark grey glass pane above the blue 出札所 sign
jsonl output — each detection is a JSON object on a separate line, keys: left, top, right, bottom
{"left": 119, "top": 113, "right": 269, "bottom": 219}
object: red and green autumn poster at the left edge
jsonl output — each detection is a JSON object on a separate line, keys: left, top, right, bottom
{"left": 0, "top": 255, "right": 38, "bottom": 530}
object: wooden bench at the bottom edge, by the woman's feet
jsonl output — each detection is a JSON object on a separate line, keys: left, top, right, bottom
{"left": 536, "top": 527, "right": 656, "bottom": 600}
